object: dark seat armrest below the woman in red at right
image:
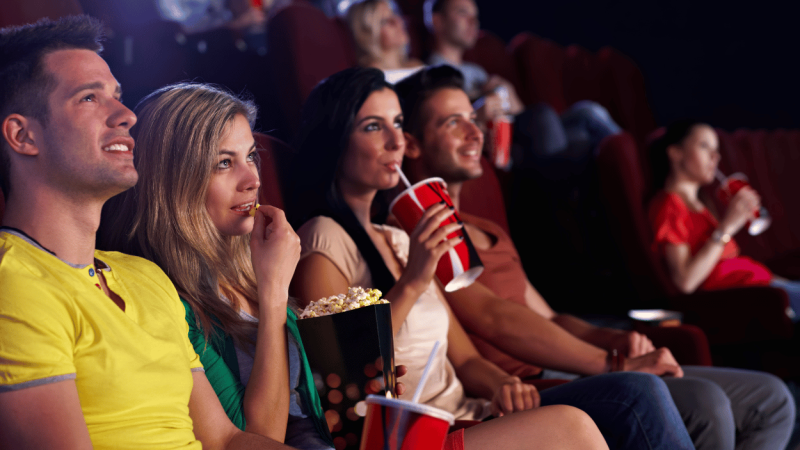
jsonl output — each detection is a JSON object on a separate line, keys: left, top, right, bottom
{"left": 670, "top": 286, "right": 793, "bottom": 345}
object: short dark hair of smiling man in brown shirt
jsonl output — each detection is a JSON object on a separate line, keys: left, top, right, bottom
{"left": 394, "top": 64, "right": 464, "bottom": 139}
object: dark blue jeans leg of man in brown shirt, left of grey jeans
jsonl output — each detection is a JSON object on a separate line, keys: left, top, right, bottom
{"left": 541, "top": 372, "right": 694, "bottom": 450}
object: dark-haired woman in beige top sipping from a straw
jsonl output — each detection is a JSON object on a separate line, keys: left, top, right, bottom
{"left": 289, "top": 68, "right": 664, "bottom": 449}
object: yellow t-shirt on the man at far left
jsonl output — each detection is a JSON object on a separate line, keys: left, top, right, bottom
{"left": 0, "top": 229, "right": 202, "bottom": 449}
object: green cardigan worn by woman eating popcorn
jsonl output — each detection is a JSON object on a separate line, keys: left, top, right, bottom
{"left": 181, "top": 298, "right": 333, "bottom": 447}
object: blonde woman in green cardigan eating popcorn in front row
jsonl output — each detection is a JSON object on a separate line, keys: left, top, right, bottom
{"left": 100, "top": 84, "right": 332, "bottom": 449}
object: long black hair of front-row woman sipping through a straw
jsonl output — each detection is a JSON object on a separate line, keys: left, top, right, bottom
{"left": 286, "top": 67, "right": 395, "bottom": 292}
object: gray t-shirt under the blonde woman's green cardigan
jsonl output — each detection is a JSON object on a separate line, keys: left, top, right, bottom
{"left": 236, "top": 311, "right": 333, "bottom": 450}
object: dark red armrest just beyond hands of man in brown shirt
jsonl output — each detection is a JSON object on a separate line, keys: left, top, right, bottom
{"left": 638, "top": 325, "right": 712, "bottom": 366}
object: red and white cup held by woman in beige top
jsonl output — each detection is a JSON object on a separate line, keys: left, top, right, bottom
{"left": 389, "top": 178, "right": 483, "bottom": 292}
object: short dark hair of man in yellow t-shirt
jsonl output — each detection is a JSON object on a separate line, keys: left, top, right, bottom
{"left": 0, "top": 15, "right": 103, "bottom": 197}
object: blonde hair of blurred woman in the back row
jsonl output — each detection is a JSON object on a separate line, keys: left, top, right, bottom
{"left": 346, "top": 0, "right": 392, "bottom": 67}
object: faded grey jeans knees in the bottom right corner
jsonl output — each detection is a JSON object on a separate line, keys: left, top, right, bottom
{"left": 664, "top": 366, "right": 795, "bottom": 450}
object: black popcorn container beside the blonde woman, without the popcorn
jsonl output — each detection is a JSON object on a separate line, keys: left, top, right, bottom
{"left": 297, "top": 304, "right": 396, "bottom": 450}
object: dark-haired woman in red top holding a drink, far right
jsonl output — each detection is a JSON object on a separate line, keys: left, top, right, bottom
{"left": 649, "top": 120, "right": 800, "bottom": 321}
